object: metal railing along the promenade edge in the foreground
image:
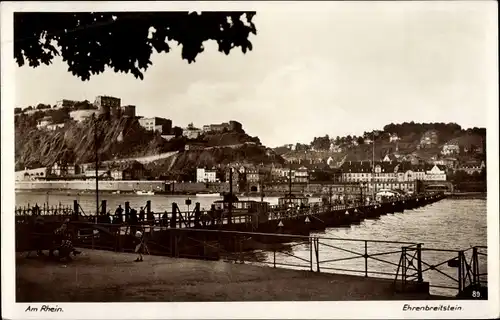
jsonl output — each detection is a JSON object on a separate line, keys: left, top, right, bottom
{"left": 56, "top": 223, "right": 487, "bottom": 298}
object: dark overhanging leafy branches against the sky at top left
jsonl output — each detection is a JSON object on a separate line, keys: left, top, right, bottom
{"left": 14, "top": 11, "right": 257, "bottom": 81}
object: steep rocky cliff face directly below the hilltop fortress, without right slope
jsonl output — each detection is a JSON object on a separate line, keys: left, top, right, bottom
{"left": 15, "top": 117, "right": 180, "bottom": 169}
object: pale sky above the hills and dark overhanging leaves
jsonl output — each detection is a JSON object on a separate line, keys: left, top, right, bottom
{"left": 11, "top": 1, "right": 498, "bottom": 147}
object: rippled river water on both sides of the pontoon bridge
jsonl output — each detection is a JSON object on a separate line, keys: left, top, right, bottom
{"left": 16, "top": 192, "right": 487, "bottom": 295}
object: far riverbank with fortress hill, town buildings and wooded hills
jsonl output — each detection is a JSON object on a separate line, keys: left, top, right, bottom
{"left": 15, "top": 96, "right": 486, "bottom": 196}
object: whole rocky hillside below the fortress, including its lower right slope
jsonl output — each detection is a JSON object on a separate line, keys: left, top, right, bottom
{"left": 15, "top": 112, "right": 283, "bottom": 172}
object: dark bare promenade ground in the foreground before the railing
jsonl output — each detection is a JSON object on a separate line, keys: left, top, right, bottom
{"left": 16, "top": 250, "right": 443, "bottom": 302}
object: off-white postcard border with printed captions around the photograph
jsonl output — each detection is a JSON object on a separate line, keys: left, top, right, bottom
{"left": 0, "top": 1, "right": 500, "bottom": 319}
